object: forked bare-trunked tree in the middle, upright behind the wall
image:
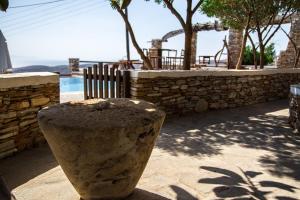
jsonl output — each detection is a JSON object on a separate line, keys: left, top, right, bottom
{"left": 151, "top": 0, "right": 204, "bottom": 70}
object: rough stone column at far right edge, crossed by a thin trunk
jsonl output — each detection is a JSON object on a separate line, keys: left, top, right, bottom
{"left": 277, "top": 13, "right": 300, "bottom": 68}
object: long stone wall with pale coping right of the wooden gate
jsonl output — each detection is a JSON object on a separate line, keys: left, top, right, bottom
{"left": 131, "top": 69, "right": 300, "bottom": 114}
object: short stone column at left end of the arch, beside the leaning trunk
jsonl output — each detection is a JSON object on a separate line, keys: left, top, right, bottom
{"left": 148, "top": 39, "right": 162, "bottom": 69}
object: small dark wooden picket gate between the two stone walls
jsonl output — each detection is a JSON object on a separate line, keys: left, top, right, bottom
{"left": 83, "top": 63, "right": 130, "bottom": 99}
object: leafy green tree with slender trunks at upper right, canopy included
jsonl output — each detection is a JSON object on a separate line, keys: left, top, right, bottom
{"left": 202, "top": 0, "right": 300, "bottom": 68}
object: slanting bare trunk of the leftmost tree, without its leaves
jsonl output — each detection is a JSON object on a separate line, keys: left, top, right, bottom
{"left": 117, "top": 7, "right": 153, "bottom": 70}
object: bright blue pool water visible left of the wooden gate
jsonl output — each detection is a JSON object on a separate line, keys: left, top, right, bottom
{"left": 60, "top": 77, "right": 83, "bottom": 93}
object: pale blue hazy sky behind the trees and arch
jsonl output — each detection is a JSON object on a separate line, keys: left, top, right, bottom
{"left": 0, "top": 0, "right": 289, "bottom": 67}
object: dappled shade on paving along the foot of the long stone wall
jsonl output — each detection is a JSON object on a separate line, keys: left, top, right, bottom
{"left": 157, "top": 100, "right": 300, "bottom": 180}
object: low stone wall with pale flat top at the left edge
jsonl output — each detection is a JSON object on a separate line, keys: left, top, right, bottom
{"left": 0, "top": 73, "right": 59, "bottom": 158}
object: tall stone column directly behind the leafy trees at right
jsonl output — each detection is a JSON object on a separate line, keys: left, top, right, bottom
{"left": 228, "top": 29, "right": 243, "bottom": 68}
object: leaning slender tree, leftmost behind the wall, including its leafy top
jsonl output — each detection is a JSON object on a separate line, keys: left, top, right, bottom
{"left": 110, "top": 0, "right": 153, "bottom": 69}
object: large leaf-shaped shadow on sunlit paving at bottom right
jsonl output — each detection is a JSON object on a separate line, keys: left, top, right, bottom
{"left": 198, "top": 166, "right": 299, "bottom": 200}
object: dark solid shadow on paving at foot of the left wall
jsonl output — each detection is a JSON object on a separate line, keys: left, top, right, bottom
{"left": 0, "top": 144, "right": 58, "bottom": 190}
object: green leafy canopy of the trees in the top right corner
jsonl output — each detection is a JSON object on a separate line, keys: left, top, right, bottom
{"left": 201, "top": 0, "right": 300, "bottom": 29}
